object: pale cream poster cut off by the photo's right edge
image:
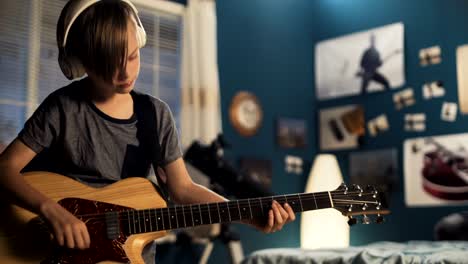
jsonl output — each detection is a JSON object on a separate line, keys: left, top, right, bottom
{"left": 457, "top": 45, "right": 468, "bottom": 114}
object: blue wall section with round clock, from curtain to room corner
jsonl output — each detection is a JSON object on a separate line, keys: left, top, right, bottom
{"left": 214, "top": 0, "right": 319, "bottom": 263}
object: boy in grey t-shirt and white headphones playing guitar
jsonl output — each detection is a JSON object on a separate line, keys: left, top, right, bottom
{"left": 0, "top": 0, "right": 295, "bottom": 262}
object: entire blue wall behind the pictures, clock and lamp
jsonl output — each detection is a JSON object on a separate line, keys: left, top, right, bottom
{"left": 215, "top": 0, "right": 468, "bottom": 257}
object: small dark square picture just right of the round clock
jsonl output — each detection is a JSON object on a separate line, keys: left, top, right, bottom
{"left": 276, "top": 117, "right": 307, "bottom": 148}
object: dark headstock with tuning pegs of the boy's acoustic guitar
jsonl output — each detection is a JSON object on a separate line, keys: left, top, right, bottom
{"left": 331, "top": 183, "right": 390, "bottom": 225}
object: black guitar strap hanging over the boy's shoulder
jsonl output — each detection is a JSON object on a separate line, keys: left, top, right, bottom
{"left": 134, "top": 94, "right": 169, "bottom": 202}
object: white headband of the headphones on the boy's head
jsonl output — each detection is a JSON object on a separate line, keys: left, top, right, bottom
{"left": 59, "top": 0, "right": 143, "bottom": 48}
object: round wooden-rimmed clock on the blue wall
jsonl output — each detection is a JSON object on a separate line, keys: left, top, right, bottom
{"left": 229, "top": 91, "right": 263, "bottom": 137}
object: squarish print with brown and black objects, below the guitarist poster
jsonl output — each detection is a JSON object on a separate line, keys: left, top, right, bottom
{"left": 319, "top": 105, "right": 366, "bottom": 150}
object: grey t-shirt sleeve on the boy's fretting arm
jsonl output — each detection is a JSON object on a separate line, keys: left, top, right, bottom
{"left": 158, "top": 102, "right": 182, "bottom": 166}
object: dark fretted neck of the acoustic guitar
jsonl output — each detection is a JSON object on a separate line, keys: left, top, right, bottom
{"left": 122, "top": 192, "right": 333, "bottom": 235}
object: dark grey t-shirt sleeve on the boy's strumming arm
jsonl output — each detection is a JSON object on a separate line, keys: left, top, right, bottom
{"left": 18, "top": 94, "right": 60, "bottom": 153}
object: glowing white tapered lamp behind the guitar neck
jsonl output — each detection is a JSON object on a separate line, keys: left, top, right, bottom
{"left": 301, "top": 154, "right": 349, "bottom": 249}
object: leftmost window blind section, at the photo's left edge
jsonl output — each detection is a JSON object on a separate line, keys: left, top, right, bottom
{"left": 0, "top": 0, "right": 31, "bottom": 151}
